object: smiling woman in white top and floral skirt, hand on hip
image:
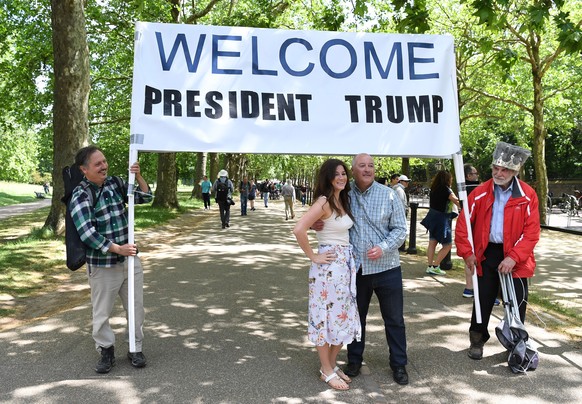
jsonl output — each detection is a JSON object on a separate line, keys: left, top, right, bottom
{"left": 293, "top": 159, "right": 361, "bottom": 390}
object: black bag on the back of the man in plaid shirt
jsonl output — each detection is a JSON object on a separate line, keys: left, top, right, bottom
{"left": 61, "top": 164, "right": 123, "bottom": 271}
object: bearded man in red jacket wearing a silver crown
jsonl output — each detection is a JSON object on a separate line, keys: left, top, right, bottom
{"left": 455, "top": 142, "right": 540, "bottom": 359}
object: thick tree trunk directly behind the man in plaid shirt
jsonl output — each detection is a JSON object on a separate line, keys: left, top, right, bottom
{"left": 44, "top": 0, "right": 90, "bottom": 234}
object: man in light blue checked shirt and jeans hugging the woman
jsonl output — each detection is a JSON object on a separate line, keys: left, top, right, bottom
{"left": 320, "top": 154, "right": 408, "bottom": 385}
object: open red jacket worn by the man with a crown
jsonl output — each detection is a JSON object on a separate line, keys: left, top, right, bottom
{"left": 455, "top": 177, "right": 540, "bottom": 278}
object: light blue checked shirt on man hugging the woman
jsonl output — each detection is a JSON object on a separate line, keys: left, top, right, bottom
{"left": 350, "top": 181, "right": 406, "bottom": 275}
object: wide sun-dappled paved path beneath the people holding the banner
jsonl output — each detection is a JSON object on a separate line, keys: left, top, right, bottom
{"left": 0, "top": 201, "right": 582, "bottom": 404}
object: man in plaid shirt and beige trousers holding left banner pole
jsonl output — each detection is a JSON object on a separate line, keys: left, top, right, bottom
{"left": 69, "top": 146, "right": 152, "bottom": 373}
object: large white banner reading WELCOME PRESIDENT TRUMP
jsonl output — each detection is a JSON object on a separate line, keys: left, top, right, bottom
{"left": 131, "top": 22, "right": 460, "bottom": 158}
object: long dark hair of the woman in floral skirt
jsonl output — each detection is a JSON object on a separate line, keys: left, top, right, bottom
{"left": 313, "top": 159, "right": 354, "bottom": 220}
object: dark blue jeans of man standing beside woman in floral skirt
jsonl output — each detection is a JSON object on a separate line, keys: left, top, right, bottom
{"left": 348, "top": 266, "right": 408, "bottom": 366}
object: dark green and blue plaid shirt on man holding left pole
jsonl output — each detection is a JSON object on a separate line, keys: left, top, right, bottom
{"left": 69, "top": 177, "right": 152, "bottom": 267}
